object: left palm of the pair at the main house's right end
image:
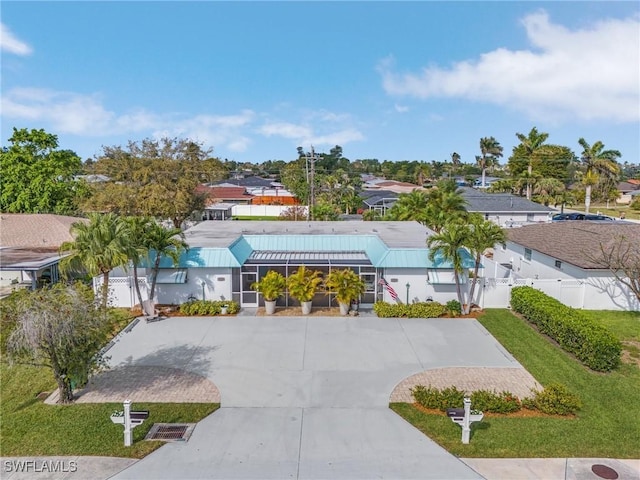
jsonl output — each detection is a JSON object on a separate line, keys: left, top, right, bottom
{"left": 427, "top": 222, "right": 469, "bottom": 314}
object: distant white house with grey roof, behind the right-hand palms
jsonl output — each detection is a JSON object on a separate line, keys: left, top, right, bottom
{"left": 460, "top": 187, "right": 556, "bottom": 227}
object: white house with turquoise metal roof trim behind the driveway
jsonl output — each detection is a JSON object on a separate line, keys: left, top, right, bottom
{"left": 104, "top": 221, "right": 473, "bottom": 307}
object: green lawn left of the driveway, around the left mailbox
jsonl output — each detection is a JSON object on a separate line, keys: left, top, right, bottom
{"left": 0, "top": 361, "right": 219, "bottom": 458}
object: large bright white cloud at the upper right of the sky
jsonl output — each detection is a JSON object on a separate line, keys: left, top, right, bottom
{"left": 378, "top": 11, "right": 640, "bottom": 122}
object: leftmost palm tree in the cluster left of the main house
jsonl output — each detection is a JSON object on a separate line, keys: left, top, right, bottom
{"left": 60, "top": 213, "right": 129, "bottom": 308}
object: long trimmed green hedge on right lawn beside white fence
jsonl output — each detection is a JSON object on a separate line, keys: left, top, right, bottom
{"left": 511, "top": 287, "right": 622, "bottom": 372}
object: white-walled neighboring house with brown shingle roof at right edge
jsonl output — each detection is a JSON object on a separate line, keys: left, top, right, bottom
{"left": 493, "top": 221, "right": 640, "bottom": 310}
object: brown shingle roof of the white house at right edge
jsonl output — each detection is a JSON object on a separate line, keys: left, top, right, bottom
{"left": 507, "top": 221, "right": 640, "bottom": 269}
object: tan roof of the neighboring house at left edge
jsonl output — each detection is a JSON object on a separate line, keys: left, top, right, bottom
{"left": 0, "top": 213, "right": 87, "bottom": 248}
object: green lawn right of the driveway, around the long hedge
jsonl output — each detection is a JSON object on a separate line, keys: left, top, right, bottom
{"left": 391, "top": 310, "right": 640, "bottom": 458}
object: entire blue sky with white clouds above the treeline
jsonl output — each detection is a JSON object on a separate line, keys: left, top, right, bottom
{"left": 0, "top": 1, "right": 640, "bottom": 163}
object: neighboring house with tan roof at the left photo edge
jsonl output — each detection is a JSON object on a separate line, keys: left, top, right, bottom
{"left": 0, "top": 213, "right": 85, "bottom": 293}
